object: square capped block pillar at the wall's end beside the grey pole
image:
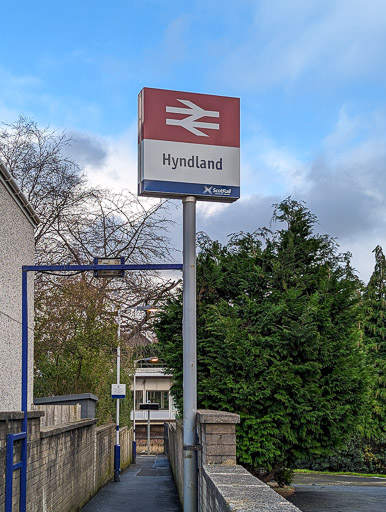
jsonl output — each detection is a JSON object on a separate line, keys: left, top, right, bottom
{"left": 197, "top": 409, "right": 240, "bottom": 467}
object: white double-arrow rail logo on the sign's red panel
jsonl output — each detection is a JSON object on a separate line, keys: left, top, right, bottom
{"left": 166, "top": 100, "right": 220, "bottom": 137}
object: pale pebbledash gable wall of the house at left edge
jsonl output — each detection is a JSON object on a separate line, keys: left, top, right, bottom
{"left": 0, "top": 181, "right": 35, "bottom": 411}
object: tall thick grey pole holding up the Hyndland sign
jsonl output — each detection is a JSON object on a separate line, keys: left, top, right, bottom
{"left": 182, "top": 196, "right": 197, "bottom": 512}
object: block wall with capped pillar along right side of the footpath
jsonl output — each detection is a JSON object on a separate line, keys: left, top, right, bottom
{"left": 168, "top": 410, "right": 300, "bottom": 512}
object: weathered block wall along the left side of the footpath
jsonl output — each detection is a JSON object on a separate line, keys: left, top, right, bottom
{"left": 0, "top": 411, "right": 132, "bottom": 512}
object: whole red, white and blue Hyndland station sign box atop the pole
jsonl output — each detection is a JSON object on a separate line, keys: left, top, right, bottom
{"left": 138, "top": 87, "right": 240, "bottom": 202}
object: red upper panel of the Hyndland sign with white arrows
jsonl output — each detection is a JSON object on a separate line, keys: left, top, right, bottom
{"left": 138, "top": 87, "right": 240, "bottom": 148}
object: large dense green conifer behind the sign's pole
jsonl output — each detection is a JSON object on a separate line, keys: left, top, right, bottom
{"left": 157, "top": 198, "right": 368, "bottom": 479}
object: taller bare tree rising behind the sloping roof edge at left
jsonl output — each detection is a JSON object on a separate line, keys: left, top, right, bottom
{"left": 0, "top": 116, "right": 90, "bottom": 254}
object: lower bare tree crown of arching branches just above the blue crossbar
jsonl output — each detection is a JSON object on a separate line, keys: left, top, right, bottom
{"left": 54, "top": 189, "right": 176, "bottom": 264}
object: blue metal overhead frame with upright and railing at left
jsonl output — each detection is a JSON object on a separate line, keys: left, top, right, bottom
{"left": 5, "top": 263, "right": 183, "bottom": 512}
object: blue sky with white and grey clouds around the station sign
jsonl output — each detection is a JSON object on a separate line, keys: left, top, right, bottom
{"left": 0, "top": 0, "right": 386, "bottom": 281}
